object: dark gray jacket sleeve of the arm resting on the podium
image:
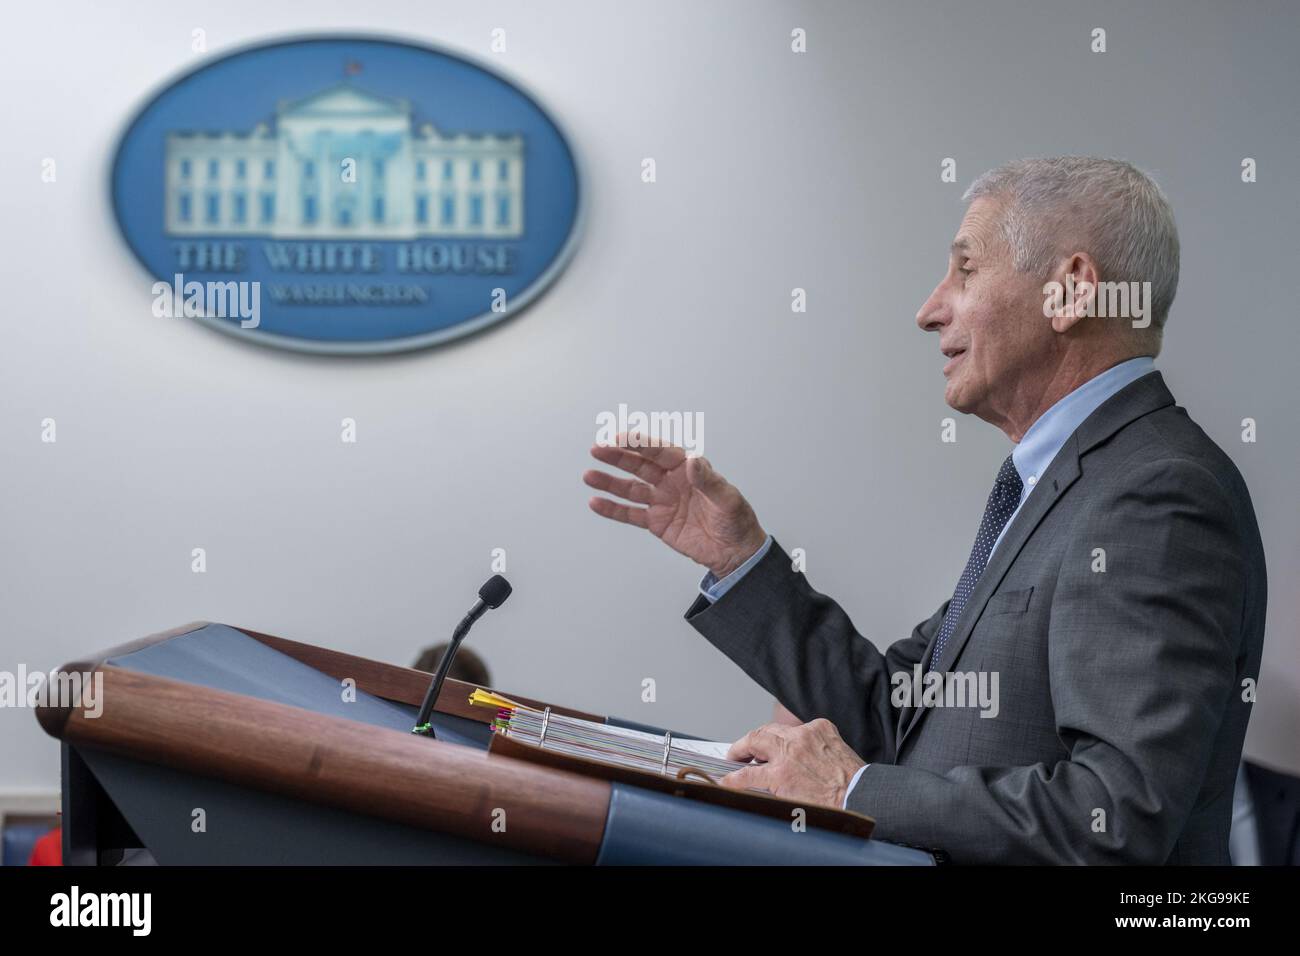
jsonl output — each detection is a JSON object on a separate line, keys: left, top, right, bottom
{"left": 849, "top": 459, "right": 1244, "bottom": 864}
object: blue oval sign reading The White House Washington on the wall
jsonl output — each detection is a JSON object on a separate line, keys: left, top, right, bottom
{"left": 111, "top": 35, "right": 582, "bottom": 354}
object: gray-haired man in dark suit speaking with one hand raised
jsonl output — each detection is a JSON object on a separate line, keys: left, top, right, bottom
{"left": 584, "top": 157, "right": 1266, "bottom": 864}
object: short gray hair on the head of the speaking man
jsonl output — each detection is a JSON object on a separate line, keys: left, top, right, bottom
{"left": 962, "top": 156, "right": 1178, "bottom": 336}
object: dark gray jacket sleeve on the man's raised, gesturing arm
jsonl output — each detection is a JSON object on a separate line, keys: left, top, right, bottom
{"left": 686, "top": 540, "right": 948, "bottom": 764}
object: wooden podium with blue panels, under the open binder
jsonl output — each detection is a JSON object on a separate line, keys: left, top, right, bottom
{"left": 36, "top": 622, "right": 935, "bottom": 865}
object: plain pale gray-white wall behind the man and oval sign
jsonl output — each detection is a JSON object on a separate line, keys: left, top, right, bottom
{"left": 0, "top": 0, "right": 1300, "bottom": 788}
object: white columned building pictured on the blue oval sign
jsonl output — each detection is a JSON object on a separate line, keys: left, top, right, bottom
{"left": 164, "top": 83, "right": 524, "bottom": 239}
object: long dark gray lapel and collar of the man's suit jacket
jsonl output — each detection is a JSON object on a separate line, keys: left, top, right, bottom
{"left": 896, "top": 372, "right": 1174, "bottom": 754}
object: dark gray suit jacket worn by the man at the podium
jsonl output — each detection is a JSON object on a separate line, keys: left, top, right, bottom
{"left": 686, "top": 372, "right": 1266, "bottom": 865}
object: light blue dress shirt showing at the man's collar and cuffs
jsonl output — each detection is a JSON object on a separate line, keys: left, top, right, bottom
{"left": 699, "top": 355, "right": 1156, "bottom": 806}
